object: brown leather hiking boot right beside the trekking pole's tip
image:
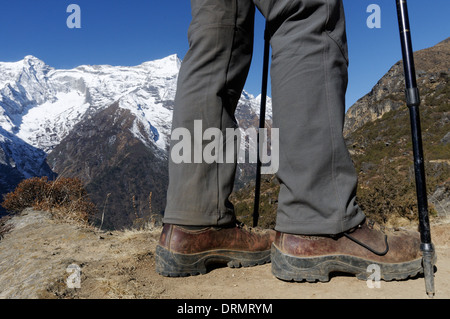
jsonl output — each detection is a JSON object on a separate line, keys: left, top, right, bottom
{"left": 271, "top": 221, "right": 423, "bottom": 282}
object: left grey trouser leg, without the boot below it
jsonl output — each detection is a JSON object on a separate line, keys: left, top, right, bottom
{"left": 164, "top": 0, "right": 254, "bottom": 225}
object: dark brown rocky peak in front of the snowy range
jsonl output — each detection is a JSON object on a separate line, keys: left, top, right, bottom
{"left": 47, "top": 102, "right": 168, "bottom": 229}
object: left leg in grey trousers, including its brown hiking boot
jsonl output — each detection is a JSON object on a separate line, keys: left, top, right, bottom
{"left": 156, "top": 0, "right": 275, "bottom": 276}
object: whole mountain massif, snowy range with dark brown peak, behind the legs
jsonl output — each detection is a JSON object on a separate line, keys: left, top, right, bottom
{"left": 0, "top": 55, "right": 271, "bottom": 228}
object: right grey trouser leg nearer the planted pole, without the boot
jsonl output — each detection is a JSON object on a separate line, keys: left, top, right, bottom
{"left": 255, "top": 0, "right": 364, "bottom": 234}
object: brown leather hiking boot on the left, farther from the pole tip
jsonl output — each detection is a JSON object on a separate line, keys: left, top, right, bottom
{"left": 156, "top": 224, "right": 275, "bottom": 277}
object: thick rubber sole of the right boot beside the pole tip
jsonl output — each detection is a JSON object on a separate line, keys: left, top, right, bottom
{"left": 271, "top": 244, "right": 423, "bottom": 282}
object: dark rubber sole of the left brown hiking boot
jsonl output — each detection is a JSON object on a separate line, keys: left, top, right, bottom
{"left": 155, "top": 245, "right": 270, "bottom": 277}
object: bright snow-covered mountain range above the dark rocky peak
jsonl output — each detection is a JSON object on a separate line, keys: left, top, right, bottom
{"left": 0, "top": 55, "right": 180, "bottom": 153}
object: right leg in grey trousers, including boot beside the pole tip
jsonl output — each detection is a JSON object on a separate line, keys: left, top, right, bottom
{"left": 255, "top": 0, "right": 422, "bottom": 281}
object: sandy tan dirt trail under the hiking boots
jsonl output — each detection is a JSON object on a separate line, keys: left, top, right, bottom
{"left": 0, "top": 210, "right": 450, "bottom": 299}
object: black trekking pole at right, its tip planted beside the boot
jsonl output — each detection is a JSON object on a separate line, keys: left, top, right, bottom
{"left": 396, "top": 0, "right": 434, "bottom": 297}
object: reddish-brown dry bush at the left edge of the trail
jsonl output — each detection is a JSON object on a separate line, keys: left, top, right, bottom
{"left": 1, "top": 177, "right": 96, "bottom": 224}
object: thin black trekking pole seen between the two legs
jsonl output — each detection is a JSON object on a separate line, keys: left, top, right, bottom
{"left": 253, "top": 20, "right": 270, "bottom": 227}
